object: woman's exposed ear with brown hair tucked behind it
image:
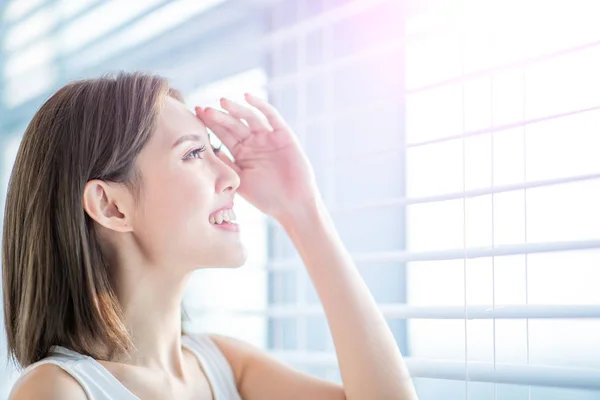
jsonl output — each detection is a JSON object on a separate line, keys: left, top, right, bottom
{"left": 83, "top": 179, "right": 133, "bottom": 232}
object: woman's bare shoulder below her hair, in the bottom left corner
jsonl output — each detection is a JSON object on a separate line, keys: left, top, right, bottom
{"left": 9, "top": 363, "right": 87, "bottom": 400}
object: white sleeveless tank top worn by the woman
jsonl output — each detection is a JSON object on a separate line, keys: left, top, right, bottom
{"left": 12, "top": 335, "right": 241, "bottom": 400}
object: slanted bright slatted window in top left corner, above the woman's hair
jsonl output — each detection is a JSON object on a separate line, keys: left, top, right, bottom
{"left": 0, "top": 0, "right": 224, "bottom": 108}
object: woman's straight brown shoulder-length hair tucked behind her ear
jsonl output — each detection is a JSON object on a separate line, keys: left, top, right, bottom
{"left": 2, "top": 73, "right": 180, "bottom": 367}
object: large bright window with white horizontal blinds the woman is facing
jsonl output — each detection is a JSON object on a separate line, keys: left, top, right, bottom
{"left": 269, "top": 0, "right": 600, "bottom": 400}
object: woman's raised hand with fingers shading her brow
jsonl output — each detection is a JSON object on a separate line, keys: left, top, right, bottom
{"left": 199, "top": 97, "right": 316, "bottom": 217}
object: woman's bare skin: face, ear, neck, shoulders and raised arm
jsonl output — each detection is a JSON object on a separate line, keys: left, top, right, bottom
{"left": 10, "top": 95, "right": 417, "bottom": 400}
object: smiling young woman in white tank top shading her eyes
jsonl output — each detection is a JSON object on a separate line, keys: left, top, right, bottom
{"left": 2, "top": 73, "right": 416, "bottom": 400}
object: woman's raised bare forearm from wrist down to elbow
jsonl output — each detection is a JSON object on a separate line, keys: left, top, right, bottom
{"left": 280, "top": 197, "right": 416, "bottom": 400}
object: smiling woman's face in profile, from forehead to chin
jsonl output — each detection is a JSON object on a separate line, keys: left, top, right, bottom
{"left": 132, "top": 97, "right": 246, "bottom": 270}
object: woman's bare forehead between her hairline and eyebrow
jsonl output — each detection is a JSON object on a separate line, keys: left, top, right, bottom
{"left": 150, "top": 96, "right": 208, "bottom": 149}
